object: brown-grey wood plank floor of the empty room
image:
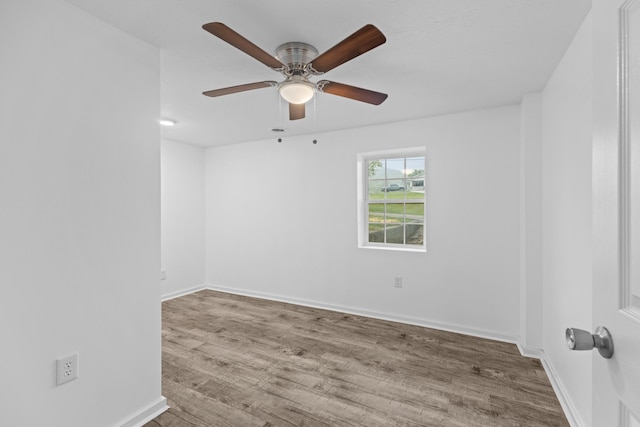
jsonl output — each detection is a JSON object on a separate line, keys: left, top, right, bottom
{"left": 145, "top": 291, "right": 569, "bottom": 427}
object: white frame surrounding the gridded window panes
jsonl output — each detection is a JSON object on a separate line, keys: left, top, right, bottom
{"left": 357, "top": 147, "right": 427, "bottom": 252}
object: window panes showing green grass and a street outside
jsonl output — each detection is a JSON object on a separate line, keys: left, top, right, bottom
{"left": 367, "top": 156, "right": 425, "bottom": 246}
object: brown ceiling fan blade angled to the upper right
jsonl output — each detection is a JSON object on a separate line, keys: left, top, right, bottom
{"left": 310, "top": 24, "right": 387, "bottom": 74}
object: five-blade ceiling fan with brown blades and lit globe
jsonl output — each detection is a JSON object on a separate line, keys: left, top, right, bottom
{"left": 202, "top": 22, "right": 387, "bottom": 120}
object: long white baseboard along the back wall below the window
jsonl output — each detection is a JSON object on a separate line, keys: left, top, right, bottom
{"left": 205, "top": 285, "right": 518, "bottom": 344}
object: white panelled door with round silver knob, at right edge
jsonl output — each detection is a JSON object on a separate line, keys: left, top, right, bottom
{"left": 592, "top": 0, "right": 640, "bottom": 427}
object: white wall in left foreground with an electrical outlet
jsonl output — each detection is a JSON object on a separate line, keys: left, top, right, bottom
{"left": 0, "top": 0, "right": 164, "bottom": 427}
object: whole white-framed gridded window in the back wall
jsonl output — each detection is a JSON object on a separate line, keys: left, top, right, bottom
{"left": 359, "top": 150, "right": 425, "bottom": 251}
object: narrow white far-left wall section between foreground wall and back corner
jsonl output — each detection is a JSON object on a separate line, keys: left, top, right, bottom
{"left": 161, "top": 140, "right": 206, "bottom": 298}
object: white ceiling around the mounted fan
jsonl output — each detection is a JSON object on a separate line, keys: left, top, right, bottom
{"left": 67, "top": 0, "right": 591, "bottom": 146}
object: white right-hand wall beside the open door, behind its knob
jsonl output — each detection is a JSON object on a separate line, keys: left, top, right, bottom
{"left": 542, "top": 10, "right": 593, "bottom": 426}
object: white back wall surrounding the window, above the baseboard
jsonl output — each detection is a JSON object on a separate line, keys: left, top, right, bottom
{"left": 206, "top": 106, "right": 520, "bottom": 340}
